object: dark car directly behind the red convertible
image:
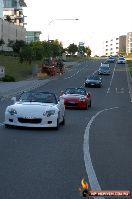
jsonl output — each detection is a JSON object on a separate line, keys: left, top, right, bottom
{"left": 85, "top": 74, "right": 102, "bottom": 87}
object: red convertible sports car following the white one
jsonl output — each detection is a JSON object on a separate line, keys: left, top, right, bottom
{"left": 60, "top": 88, "right": 91, "bottom": 109}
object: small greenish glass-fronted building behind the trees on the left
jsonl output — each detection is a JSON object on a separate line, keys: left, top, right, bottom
{"left": 26, "top": 31, "right": 41, "bottom": 43}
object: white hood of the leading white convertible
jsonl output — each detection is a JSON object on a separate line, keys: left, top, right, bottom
{"left": 7, "top": 102, "right": 57, "bottom": 116}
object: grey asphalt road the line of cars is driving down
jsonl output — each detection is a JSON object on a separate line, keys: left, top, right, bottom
{"left": 0, "top": 60, "right": 132, "bottom": 199}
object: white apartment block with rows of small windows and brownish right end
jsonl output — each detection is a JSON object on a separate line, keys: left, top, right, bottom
{"left": 104, "top": 35, "right": 126, "bottom": 56}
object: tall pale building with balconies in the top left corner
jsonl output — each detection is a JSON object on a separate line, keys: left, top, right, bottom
{"left": 3, "top": 0, "right": 26, "bottom": 26}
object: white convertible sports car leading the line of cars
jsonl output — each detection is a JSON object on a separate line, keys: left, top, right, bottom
{"left": 4, "top": 91, "right": 65, "bottom": 129}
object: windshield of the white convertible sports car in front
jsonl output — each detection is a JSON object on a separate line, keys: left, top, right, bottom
{"left": 19, "top": 92, "right": 57, "bottom": 104}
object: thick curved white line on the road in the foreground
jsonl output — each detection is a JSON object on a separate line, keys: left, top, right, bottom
{"left": 83, "top": 107, "right": 119, "bottom": 194}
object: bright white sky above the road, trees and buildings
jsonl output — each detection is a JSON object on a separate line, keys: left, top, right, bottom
{"left": 24, "top": 0, "right": 132, "bottom": 54}
